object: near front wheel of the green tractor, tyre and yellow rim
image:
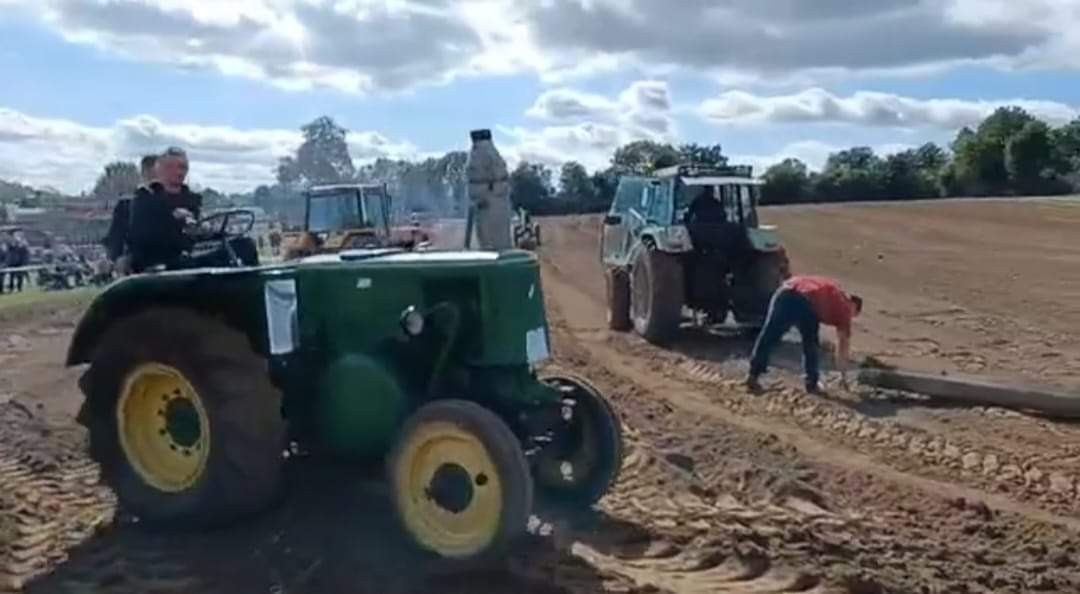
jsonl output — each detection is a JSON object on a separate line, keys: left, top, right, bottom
{"left": 387, "top": 400, "right": 532, "bottom": 562}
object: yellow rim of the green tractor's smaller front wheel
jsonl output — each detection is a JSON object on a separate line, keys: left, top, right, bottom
{"left": 395, "top": 422, "right": 502, "bottom": 557}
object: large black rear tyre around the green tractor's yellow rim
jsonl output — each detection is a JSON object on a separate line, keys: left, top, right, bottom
{"left": 80, "top": 308, "right": 285, "bottom": 528}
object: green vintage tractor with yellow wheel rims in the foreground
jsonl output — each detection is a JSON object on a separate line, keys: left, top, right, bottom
{"left": 67, "top": 213, "right": 622, "bottom": 559}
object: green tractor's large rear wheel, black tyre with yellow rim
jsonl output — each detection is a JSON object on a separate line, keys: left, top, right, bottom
{"left": 80, "top": 309, "right": 285, "bottom": 527}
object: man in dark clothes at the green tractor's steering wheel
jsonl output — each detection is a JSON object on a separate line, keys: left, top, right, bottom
{"left": 127, "top": 147, "right": 258, "bottom": 272}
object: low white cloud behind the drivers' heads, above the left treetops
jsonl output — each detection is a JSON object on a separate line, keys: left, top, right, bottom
{"left": 0, "top": 108, "right": 416, "bottom": 192}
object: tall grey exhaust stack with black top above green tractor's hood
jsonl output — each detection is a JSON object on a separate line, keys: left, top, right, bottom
{"left": 465, "top": 130, "right": 513, "bottom": 251}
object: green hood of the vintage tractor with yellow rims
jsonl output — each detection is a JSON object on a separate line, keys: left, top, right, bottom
{"left": 289, "top": 249, "right": 549, "bottom": 366}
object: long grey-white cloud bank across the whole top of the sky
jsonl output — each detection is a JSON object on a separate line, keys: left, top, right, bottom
{"left": 8, "top": 0, "right": 1080, "bottom": 92}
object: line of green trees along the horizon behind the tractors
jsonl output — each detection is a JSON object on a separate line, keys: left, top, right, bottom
{"left": 29, "top": 107, "right": 1080, "bottom": 225}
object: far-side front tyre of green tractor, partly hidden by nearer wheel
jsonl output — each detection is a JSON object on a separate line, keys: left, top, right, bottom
{"left": 532, "top": 376, "right": 623, "bottom": 509}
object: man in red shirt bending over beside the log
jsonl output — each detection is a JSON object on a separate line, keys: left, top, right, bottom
{"left": 746, "top": 275, "right": 863, "bottom": 394}
